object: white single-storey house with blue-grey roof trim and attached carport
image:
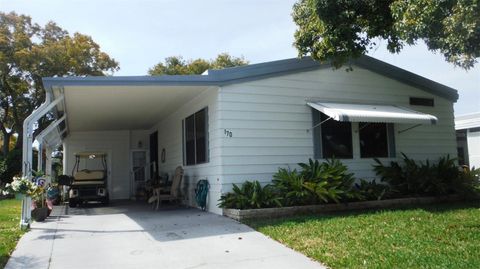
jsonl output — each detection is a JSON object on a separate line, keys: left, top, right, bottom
{"left": 24, "top": 56, "right": 458, "bottom": 213}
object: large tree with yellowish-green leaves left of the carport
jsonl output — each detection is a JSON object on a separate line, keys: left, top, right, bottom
{"left": 0, "top": 12, "right": 119, "bottom": 156}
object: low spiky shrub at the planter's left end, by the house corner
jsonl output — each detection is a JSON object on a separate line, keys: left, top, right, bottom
{"left": 218, "top": 181, "right": 282, "bottom": 209}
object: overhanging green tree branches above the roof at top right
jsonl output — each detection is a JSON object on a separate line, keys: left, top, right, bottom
{"left": 292, "top": 0, "right": 480, "bottom": 69}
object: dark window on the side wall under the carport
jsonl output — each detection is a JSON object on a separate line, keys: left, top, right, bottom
{"left": 183, "top": 108, "right": 208, "bottom": 165}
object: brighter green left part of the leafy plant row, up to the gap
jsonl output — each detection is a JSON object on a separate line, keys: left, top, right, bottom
{"left": 219, "top": 159, "right": 360, "bottom": 209}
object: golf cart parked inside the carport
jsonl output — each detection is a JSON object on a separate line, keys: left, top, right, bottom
{"left": 68, "top": 152, "right": 109, "bottom": 207}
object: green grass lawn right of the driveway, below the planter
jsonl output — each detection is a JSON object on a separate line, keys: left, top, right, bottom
{"left": 249, "top": 202, "right": 480, "bottom": 268}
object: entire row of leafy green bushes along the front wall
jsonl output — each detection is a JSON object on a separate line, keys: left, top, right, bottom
{"left": 219, "top": 154, "right": 480, "bottom": 209}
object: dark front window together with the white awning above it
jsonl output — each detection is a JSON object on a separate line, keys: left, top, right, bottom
{"left": 307, "top": 102, "right": 437, "bottom": 159}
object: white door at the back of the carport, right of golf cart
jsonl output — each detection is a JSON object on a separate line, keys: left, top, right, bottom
{"left": 131, "top": 150, "right": 148, "bottom": 197}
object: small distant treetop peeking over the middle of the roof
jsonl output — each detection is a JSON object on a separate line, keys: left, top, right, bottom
{"left": 148, "top": 53, "right": 248, "bottom": 76}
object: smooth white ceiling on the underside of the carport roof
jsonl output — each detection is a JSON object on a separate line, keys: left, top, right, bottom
{"left": 64, "top": 86, "right": 209, "bottom": 131}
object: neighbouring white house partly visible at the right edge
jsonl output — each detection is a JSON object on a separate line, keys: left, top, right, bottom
{"left": 455, "top": 113, "right": 480, "bottom": 168}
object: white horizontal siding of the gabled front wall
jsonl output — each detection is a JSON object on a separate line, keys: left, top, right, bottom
{"left": 218, "top": 67, "right": 456, "bottom": 186}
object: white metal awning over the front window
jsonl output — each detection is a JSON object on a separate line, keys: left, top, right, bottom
{"left": 307, "top": 102, "right": 438, "bottom": 124}
